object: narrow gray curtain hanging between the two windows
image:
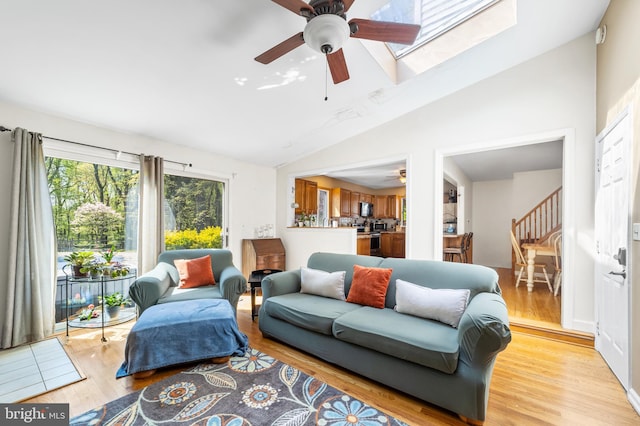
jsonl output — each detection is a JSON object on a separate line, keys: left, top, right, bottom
{"left": 138, "top": 155, "right": 164, "bottom": 274}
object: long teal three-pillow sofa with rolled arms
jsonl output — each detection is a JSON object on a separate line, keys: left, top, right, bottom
{"left": 259, "top": 253, "right": 511, "bottom": 424}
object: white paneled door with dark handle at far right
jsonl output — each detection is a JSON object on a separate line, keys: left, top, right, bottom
{"left": 595, "top": 107, "right": 632, "bottom": 389}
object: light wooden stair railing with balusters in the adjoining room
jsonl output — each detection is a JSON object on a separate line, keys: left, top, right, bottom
{"left": 511, "top": 187, "right": 562, "bottom": 269}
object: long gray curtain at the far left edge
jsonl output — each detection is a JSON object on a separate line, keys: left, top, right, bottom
{"left": 0, "top": 128, "right": 57, "bottom": 348}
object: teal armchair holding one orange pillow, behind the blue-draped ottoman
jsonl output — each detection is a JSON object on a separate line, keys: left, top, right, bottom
{"left": 129, "top": 249, "right": 247, "bottom": 314}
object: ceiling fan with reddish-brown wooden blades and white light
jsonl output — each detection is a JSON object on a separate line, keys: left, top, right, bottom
{"left": 255, "top": 0, "right": 420, "bottom": 84}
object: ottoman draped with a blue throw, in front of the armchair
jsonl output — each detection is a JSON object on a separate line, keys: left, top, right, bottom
{"left": 116, "top": 299, "right": 249, "bottom": 378}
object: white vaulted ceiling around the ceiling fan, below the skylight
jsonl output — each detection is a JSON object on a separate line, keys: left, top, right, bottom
{"left": 0, "top": 0, "right": 609, "bottom": 173}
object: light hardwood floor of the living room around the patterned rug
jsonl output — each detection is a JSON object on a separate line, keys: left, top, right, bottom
{"left": 23, "top": 294, "right": 640, "bottom": 426}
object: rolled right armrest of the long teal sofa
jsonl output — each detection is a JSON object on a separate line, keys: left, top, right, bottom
{"left": 458, "top": 293, "right": 511, "bottom": 366}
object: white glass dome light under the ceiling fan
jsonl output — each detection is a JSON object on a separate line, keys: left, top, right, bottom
{"left": 302, "top": 15, "right": 350, "bottom": 54}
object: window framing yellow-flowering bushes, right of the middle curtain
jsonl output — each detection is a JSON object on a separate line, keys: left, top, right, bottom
{"left": 164, "top": 174, "right": 227, "bottom": 250}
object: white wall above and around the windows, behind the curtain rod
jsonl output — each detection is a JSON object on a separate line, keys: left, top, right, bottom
{"left": 0, "top": 102, "right": 276, "bottom": 271}
